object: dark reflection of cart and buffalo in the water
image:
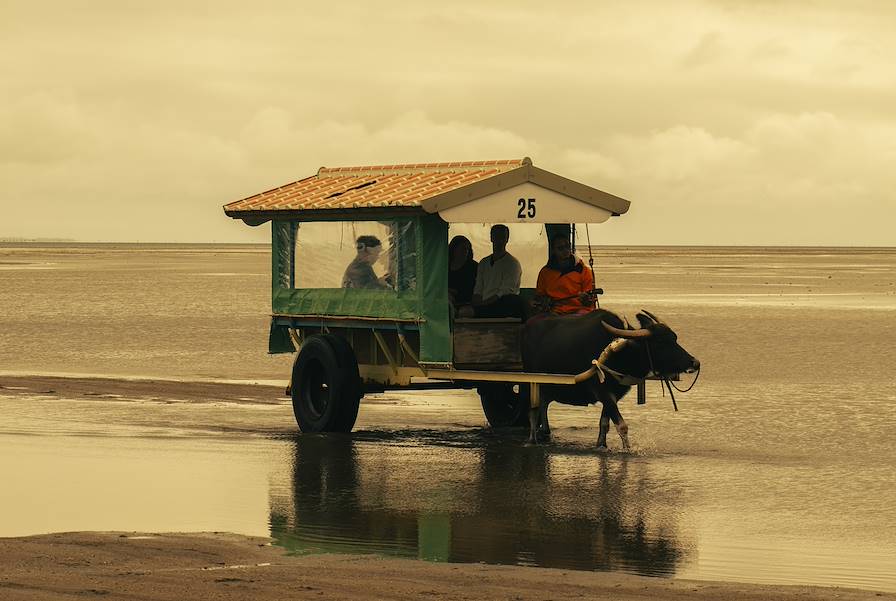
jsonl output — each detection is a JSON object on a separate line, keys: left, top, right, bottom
{"left": 270, "top": 431, "right": 686, "bottom": 576}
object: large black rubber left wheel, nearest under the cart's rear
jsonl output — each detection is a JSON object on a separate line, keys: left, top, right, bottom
{"left": 292, "top": 334, "right": 364, "bottom": 432}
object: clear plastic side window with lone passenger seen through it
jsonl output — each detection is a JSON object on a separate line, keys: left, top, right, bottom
{"left": 293, "top": 221, "right": 417, "bottom": 291}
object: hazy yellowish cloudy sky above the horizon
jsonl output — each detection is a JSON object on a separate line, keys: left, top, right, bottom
{"left": 0, "top": 0, "right": 896, "bottom": 246}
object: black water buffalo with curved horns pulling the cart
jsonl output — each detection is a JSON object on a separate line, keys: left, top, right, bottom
{"left": 522, "top": 309, "right": 700, "bottom": 449}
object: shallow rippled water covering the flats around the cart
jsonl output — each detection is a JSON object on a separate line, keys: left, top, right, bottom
{"left": 0, "top": 246, "right": 896, "bottom": 591}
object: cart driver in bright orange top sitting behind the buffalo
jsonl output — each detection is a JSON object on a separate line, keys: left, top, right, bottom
{"left": 533, "top": 234, "right": 594, "bottom": 315}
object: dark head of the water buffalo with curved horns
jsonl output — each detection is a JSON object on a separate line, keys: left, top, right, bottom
{"left": 603, "top": 310, "right": 700, "bottom": 377}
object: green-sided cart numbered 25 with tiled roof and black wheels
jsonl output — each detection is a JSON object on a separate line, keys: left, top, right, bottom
{"left": 224, "top": 158, "right": 656, "bottom": 432}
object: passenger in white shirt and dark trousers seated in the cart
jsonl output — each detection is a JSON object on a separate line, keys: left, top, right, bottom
{"left": 461, "top": 224, "right": 526, "bottom": 320}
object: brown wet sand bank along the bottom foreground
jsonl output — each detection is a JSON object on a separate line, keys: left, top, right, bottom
{"left": 0, "top": 532, "right": 896, "bottom": 601}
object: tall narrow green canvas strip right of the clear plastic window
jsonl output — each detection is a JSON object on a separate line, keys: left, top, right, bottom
{"left": 417, "top": 214, "right": 452, "bottom": 363}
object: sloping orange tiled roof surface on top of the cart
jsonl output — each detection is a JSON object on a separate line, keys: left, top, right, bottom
{"left": 224, "top": 158, "right": 531, "bottom": 216}
